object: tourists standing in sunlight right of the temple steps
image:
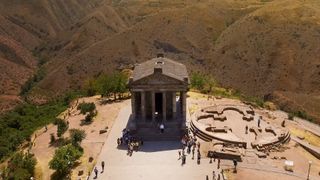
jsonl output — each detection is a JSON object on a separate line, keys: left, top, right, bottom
{"left": 178, "top": 131, "right": 201, "bottom": 165}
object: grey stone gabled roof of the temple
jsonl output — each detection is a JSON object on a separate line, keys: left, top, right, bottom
{"left": 133, "top": 57, "right": 188, "bottom": 81}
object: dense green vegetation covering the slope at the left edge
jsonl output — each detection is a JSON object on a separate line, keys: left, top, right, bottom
{"left": 0, "top": 99, "right": 67, "bottom": 161}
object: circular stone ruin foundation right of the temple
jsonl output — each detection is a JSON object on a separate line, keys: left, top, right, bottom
{"left": 191, "top": 104, "right": 290, "bottom": 150}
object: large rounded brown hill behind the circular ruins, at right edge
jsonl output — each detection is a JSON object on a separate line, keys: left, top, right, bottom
{"left": 210, "top": 0, "right": 320, "bottom": 121}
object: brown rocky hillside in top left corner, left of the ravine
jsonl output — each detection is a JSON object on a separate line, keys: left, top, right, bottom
{"left": 0, "top": 0, "right": 106, "bottom": 109}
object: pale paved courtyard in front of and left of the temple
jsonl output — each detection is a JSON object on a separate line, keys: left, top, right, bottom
{"left": 90, "top": 106, "right": 220, "bottom": 180}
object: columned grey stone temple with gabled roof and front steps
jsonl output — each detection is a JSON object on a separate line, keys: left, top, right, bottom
{"left": 129, "top": 56, "right": 189, "bottom": 140}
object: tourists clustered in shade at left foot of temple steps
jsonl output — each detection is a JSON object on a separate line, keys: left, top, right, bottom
{"left": 117, "top": 129, "right": 143, "bottom": 156}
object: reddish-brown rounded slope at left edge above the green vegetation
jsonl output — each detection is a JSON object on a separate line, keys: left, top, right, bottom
{"left": 0, "top": 35, "right": 36, "bottom": 111}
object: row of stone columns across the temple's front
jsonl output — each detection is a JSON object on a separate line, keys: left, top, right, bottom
{"left": 131, "top": 91, "right": 186, "bottom": 121}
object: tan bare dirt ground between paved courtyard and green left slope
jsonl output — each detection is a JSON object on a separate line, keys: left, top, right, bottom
{"left": 32, "top": 96, "right": 128, "bottom": 180}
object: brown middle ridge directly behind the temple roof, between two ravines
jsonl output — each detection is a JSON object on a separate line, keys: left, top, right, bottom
{"left": 33, "top": 0, "right": 255, "bottom": 93}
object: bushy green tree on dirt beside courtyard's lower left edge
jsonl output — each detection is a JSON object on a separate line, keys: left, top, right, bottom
{"left": 49, "top": 144, "right": 83, "bottom": 175}
